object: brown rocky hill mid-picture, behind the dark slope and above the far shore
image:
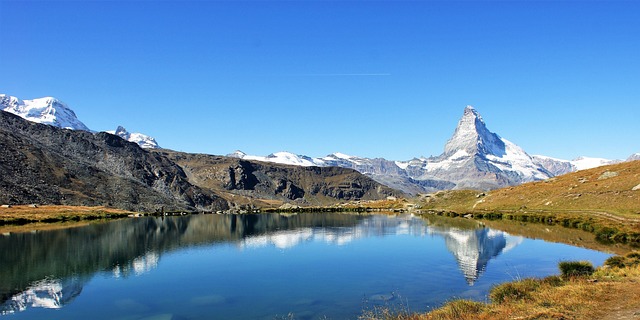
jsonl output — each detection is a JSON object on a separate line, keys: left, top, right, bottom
{"left": 155, "top": 150, "right": 401, "bottom": 206}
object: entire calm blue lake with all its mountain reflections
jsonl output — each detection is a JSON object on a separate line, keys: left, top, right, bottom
{"left": 0, "top": 213, "right": 609, "bottom": 320}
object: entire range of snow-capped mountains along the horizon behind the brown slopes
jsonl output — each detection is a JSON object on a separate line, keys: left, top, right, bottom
{"left": 0, "top": 95, "right": 640, "bottom": 194}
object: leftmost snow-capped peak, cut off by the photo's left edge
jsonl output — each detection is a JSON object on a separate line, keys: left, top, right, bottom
{"left": 0, "top": 94, "right": 91, "bottom": 131}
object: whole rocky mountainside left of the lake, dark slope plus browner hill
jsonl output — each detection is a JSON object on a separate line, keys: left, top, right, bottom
{"left": 0, "top": 111, "right": 400, "bottom": 211}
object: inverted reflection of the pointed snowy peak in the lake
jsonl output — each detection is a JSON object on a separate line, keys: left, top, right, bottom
{"left": 432, "top": 220, "right": 523, "bottom": 285}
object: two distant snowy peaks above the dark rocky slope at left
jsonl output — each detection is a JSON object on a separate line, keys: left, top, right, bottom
{"left": 0, "top": 94, "right": 160, "bottom": 148}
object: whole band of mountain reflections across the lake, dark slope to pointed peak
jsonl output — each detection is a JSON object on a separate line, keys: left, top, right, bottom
{"left": 0, "top": 213, "right": 521, "bottom": 314}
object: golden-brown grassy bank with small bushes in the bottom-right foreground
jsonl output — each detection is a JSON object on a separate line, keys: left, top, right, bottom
{"left": 361, "top": 252, "right": 640, "bottom": 320}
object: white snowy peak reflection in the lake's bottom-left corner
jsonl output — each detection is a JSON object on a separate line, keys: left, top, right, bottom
{"left": 0, "top": 278, "right": 82, "bottom": 315}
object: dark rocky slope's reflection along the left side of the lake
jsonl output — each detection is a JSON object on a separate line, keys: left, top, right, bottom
{"left": 0, "top": 214, "right": 364, "bottom": 312}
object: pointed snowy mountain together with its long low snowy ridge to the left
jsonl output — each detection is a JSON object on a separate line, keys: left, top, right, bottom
{"left": 235, "top": 106, "right": 566, "bottom": 194}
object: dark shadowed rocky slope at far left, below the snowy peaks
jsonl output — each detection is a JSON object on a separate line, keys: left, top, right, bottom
{"left": 0, "top": 112, "right": 227, "bottom": 211}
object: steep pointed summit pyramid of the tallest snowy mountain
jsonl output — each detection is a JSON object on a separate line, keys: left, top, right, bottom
{"left": 443, "top": 105, "right": 505, "bottom": 157}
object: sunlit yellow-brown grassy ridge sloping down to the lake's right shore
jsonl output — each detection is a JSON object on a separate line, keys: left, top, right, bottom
{"left": 419, "top": 161, "right": 640, "bottom": 243}
